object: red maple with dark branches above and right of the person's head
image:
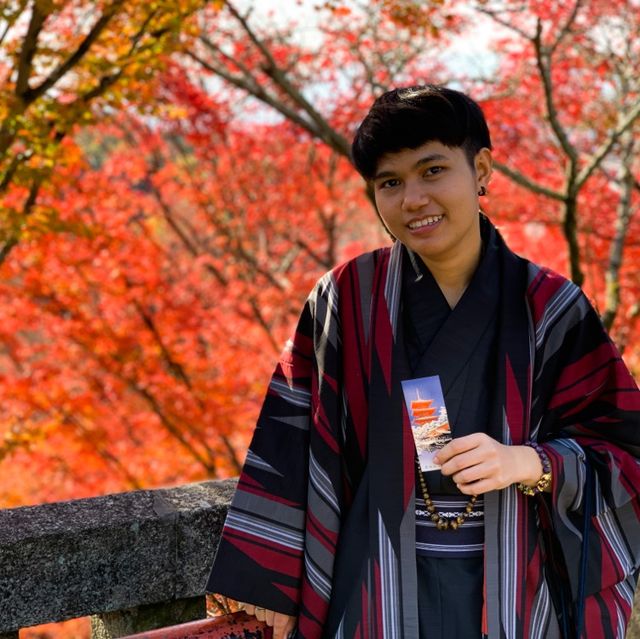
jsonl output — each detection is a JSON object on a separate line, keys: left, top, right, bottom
{"left": 189, "top": 0, "right": 640, "bottom": 348}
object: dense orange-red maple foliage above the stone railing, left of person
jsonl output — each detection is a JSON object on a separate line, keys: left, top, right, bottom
{"left": 0, "top": 90, "right": 373, "bottom": 503}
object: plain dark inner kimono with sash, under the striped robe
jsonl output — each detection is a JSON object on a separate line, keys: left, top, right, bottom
{"left": 402, "top": 222, "right": 500, "bottom": 639}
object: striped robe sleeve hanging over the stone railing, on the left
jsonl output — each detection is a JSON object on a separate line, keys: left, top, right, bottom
{"left": 207, "top": 293, "right": 314, "bottom": 615}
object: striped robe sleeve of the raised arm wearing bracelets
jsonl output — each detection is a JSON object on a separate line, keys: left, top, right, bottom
{"left": 533, "top": 272, "right": 640, "bottom": 638}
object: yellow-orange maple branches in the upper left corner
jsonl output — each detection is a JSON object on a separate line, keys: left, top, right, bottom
{"left": 0, "top": 0, "right": 204, "bottom": 262}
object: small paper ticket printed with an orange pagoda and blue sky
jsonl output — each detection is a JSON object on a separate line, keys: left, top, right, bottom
{"left": 402, "top": 375, "right": 451, "bottom": 472}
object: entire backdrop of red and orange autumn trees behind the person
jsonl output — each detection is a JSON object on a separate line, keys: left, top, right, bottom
{"left": 0, "top": 0, "right": 640, "bottom": 506}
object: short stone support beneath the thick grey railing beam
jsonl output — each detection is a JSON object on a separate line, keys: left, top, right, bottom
{"left": 91, "top": 596, "right": 207, "bottom": 639}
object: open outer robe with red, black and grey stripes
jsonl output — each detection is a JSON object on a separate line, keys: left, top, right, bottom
{"left": 207, "top": 221, "right": 640, "bottom": 639}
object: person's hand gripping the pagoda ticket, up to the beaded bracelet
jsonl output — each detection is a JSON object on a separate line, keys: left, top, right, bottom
{"left": 434, "top": 433, "right": 542, "bottom": 495}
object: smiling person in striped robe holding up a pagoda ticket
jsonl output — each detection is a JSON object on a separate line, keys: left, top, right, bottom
{"left": 208, "top": 85, "right": 640, "bottom": 639}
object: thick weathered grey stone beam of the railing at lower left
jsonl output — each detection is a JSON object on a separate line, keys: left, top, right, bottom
{"left": 0, "top": 480, "right": 235, "bottom": 633}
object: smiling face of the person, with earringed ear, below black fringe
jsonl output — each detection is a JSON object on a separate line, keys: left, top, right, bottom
{"left": 373, "top": 141, "right": 491, "bottom": 270}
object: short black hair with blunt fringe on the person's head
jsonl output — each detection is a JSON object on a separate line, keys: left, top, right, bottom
{"left": 351, "top": 84, "right": 491, "bottom": 180}
